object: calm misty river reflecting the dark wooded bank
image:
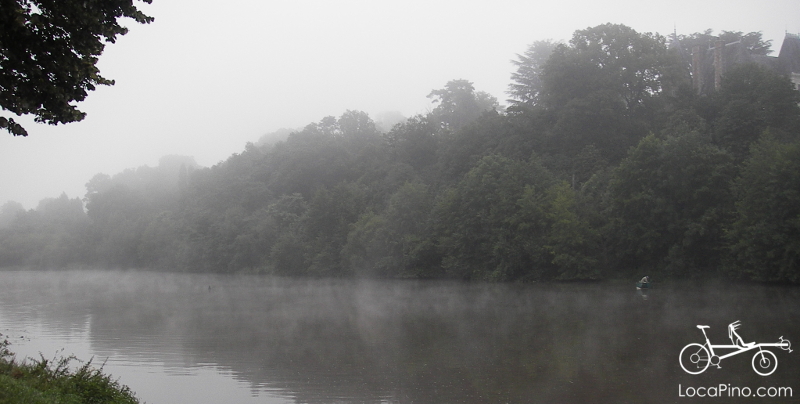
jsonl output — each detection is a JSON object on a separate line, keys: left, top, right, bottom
{"left": 0, "top": 271, "right": 800, "bottom": 404}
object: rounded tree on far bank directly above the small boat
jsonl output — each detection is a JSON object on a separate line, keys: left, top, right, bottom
{"left": 609, "top": 134, "right": 734, "bottom": 273}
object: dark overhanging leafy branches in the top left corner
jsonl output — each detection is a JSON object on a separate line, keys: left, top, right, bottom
{"left": 0, "top": 0, "right": 153, "bottom": 136}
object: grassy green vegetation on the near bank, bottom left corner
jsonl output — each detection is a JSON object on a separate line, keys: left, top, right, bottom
{"left": 0, "top": 341, "right": 139, "bottom": 404}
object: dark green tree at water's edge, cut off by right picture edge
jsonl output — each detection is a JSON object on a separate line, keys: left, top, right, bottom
{"left": 727, "top": 137, "right": 800, "bottom": 283}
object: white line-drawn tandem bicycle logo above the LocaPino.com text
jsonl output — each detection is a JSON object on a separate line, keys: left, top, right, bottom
{"left": 679, "top": 321, "right": 792, "bottom": 376}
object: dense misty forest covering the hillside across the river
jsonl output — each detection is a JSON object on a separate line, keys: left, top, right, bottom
{"left": 0, "top": 24, "right": 800, "bottom": 283}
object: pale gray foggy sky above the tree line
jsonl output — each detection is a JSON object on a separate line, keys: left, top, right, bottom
{"left": 0, "top": 0, "right": 800, "bottom": 208}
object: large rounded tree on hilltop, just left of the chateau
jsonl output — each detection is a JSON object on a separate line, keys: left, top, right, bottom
{"left": 539, "top": 24, "right": 673, "bottom": 161}
